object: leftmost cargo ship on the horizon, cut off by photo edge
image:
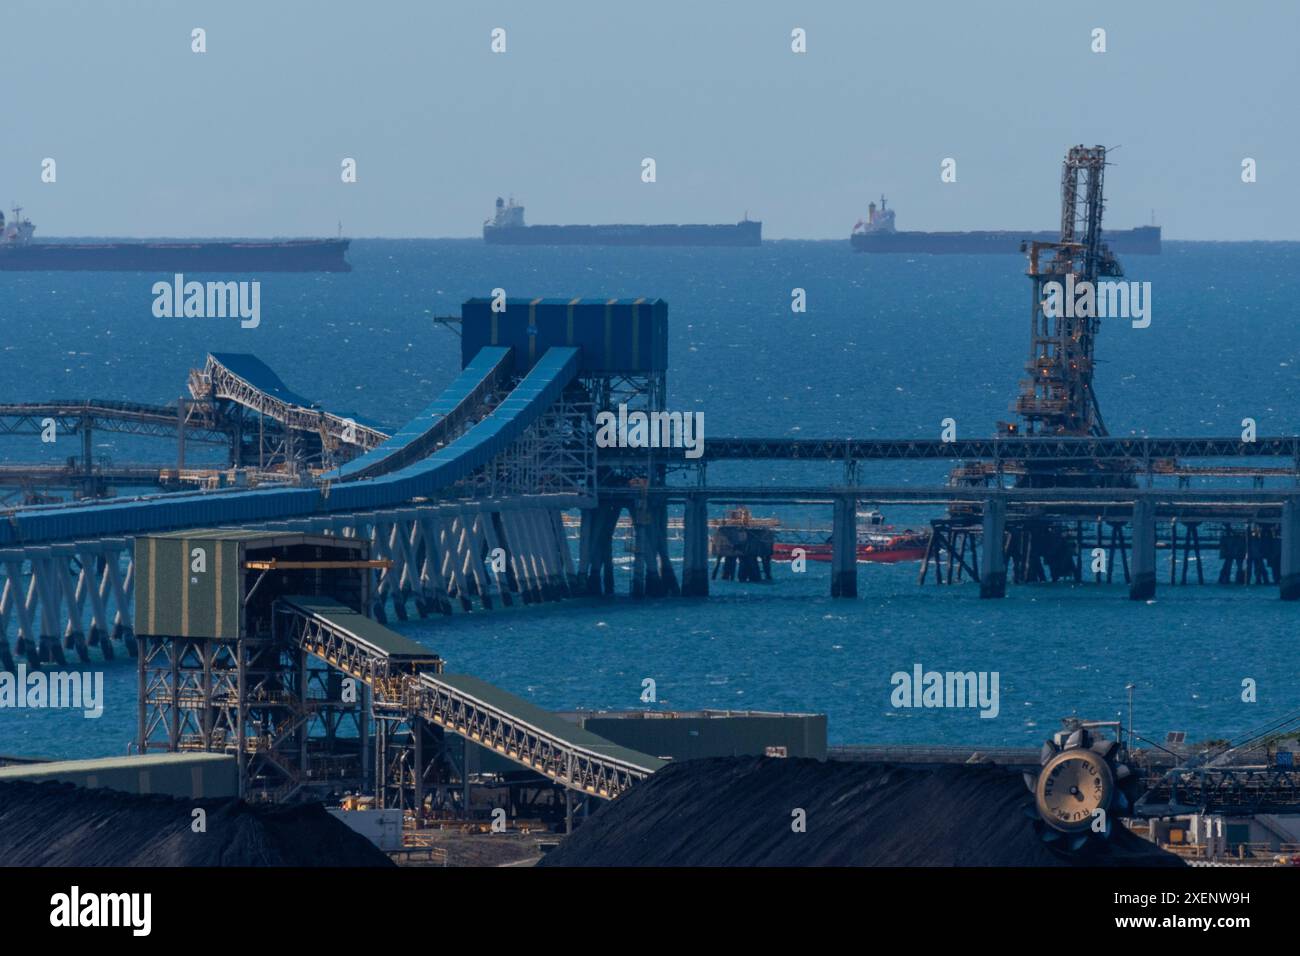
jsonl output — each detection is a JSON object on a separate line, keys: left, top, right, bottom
{"left": 0, "top": 207, "right": 352, "bottom": 272}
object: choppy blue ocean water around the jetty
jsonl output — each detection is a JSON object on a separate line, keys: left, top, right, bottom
{"left": 0, "top": 239, "right": 1300, "bottom": 756}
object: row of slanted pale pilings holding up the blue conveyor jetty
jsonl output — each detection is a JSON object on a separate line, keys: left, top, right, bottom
{"left": 0, "top": 496, "right": 588, "bottom": 670}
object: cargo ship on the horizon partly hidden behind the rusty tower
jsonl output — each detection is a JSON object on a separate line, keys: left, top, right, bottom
{"left": 849, "top": 196, "right": 1161, "bottom": 255}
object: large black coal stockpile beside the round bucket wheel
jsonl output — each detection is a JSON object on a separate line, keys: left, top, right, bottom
{"left": 538, "top": 757, "right": 1183, "bottom": 866}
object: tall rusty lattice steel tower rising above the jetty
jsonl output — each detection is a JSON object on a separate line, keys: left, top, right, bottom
{"left": 1004, "top": 146, "right": 1123, "bottom": 437}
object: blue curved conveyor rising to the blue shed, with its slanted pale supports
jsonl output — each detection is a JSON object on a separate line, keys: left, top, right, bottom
{"left": 0, "top": 346, "right": 595, "bottom": 665}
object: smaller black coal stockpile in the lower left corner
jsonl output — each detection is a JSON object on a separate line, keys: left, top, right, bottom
{"left": 0, "top": 782, "right": 393, "bottom": 866}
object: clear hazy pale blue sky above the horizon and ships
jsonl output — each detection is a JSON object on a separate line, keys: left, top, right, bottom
{"left": 0, "top": 0, "right": 1300, "bottom": 239}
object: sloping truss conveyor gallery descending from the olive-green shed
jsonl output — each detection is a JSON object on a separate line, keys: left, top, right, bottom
{"left": 276, "top": 597, "right": 664, "bottom": 800}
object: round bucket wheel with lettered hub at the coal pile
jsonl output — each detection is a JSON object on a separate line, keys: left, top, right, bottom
{"left": 1024, "top": 724, "right": 1138, "bottom": 855}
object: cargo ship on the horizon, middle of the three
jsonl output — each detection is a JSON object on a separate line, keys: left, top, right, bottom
{"left": 484, "top": 196, "right": 763, "bottom": 246}
